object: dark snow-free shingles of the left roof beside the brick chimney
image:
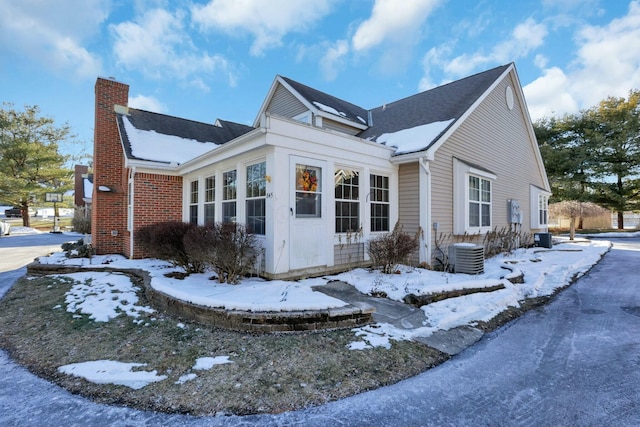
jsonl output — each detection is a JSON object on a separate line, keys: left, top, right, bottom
{"left": 117, "top": 108, "right": 254, "bottom": 160}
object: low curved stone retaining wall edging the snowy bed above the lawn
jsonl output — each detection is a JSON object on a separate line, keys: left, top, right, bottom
{"left": 27, "top": 262, "right": 375, "bottom": 332}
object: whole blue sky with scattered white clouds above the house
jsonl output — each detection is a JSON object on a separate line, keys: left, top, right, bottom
{"left": 0, "top": 0, "right": 640, "bottom": 162}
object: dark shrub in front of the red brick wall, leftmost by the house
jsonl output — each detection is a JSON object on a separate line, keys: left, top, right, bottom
{"left": 136, "top": 221, "right": 204, "bottom": 273}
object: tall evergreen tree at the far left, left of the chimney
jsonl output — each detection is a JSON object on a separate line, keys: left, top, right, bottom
{"left": 0, "top": 103, "right": 73, "bottom": 227}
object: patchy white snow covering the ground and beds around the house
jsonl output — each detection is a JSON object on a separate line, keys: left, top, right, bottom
{"left": 27, "top": 233, "right": 624, "bottom": 388}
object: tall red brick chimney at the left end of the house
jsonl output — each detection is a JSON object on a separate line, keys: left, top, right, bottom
{"left": 91, "top": 77, "right": 129, "bottom": 254}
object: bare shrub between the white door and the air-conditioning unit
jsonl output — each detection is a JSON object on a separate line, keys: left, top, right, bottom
{"left": 367, "top": 223, "right": 418, "bottom": 274}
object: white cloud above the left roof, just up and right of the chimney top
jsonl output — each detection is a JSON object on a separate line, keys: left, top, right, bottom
{"left": 110, "top": 9, "right": 236, "bottom": 90}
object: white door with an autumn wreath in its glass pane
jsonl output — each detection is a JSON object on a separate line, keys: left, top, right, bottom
{"left": 289, "top": 156, "right": 327, "bottom": 270}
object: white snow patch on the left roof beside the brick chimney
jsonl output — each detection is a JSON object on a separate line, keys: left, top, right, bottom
{"left": 122, "top": 116, "right": 218, "bottom": 164}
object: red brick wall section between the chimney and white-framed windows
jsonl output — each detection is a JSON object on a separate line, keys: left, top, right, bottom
{"left": 125, "top": 173, "right": 182, "bottom": 258}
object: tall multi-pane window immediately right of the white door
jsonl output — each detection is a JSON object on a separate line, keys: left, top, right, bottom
{"left": 334, "top": 169, "right": 360, "bottom": 233}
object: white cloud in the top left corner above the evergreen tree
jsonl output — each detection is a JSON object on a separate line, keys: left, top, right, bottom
{"left": 0, "top": 0, "right": 110, "bottom": 78}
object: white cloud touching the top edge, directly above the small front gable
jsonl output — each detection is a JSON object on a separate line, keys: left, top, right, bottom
{"left": 191, "top": 0, "right": 333, "bottom": 56}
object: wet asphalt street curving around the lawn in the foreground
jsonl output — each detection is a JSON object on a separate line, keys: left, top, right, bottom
{"left": 0, "top": 236, "right": 640, "bottom": 426}
